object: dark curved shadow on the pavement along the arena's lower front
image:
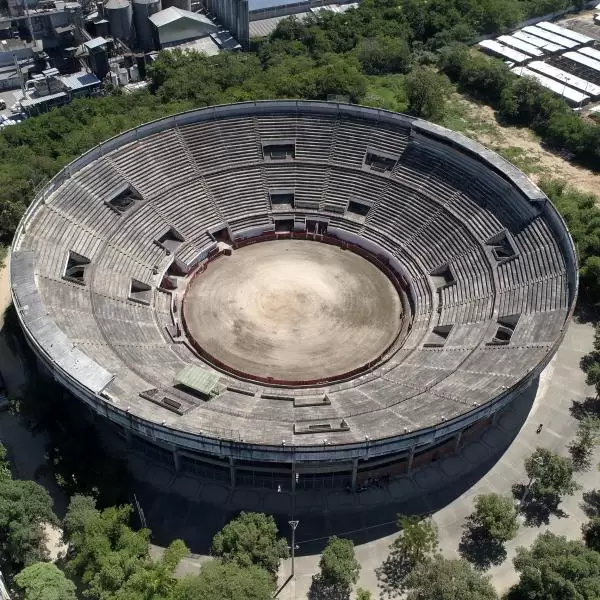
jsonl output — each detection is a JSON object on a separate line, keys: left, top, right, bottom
{"left": 123, "top": 380, "right": 538, "bottom": 555}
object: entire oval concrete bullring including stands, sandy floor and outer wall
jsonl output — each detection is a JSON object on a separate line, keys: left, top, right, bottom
{"left": 10, "top": 101, "right": 577, "bottom": 491}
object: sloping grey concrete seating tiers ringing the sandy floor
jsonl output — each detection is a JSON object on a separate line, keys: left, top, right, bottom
{"left": 12, "top": 103, "right": 575, "bottom": 447}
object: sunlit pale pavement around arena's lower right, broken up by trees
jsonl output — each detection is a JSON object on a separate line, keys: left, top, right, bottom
{"left": 279, "top": 322, "right": 598, "bottom": 600}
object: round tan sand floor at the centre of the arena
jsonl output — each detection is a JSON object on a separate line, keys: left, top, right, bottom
{"left": 184, "top": 240, "right": 402, "bottom": 381}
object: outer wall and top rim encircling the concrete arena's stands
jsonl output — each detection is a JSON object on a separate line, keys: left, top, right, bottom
{"left": 11, "top": 101, "right": 578, "bottom": 489}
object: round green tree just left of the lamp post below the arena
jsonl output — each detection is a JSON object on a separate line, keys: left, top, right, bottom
{"left": 212, "top": 512, "right": 288, "bottom": 577}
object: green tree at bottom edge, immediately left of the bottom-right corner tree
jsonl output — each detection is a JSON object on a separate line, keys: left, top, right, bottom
{"left": 406, "top": 555, "right": 498, "bottom": 600}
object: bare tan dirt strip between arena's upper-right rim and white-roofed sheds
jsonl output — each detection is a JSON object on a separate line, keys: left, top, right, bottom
{"left": 448, "top": 94, "right": 600, "bottom": 194}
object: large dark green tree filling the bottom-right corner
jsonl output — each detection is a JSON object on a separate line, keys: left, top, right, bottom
{"left": 508, "top": 532, "right": 600, "bottom": 600}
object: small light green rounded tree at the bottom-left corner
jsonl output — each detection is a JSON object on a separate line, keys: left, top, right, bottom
{"left": 14, "top": 562, "right": 77, "bottom": 600}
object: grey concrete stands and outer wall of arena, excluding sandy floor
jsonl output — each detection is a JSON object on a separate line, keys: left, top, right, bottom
{"left": 11, "top": 102, "right": 577, "bottom": 490}
